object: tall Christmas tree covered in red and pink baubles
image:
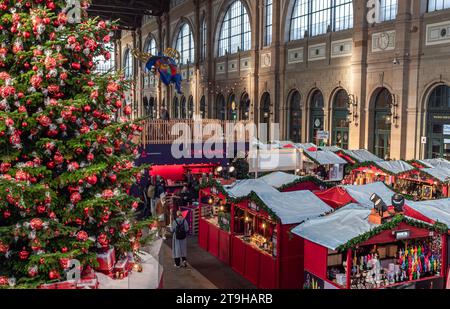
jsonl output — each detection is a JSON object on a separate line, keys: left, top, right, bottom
{"left": 0, "top": 0, "right": 153, "bottom": 287}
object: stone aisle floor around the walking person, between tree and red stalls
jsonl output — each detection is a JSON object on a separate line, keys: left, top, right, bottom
{"left": 161, "top": 237, "right": 255, "bottom": 289}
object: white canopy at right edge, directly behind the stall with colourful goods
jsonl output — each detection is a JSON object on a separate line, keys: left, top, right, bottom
{"left": 406, "top": 199, "right": 450, "bottom": 226}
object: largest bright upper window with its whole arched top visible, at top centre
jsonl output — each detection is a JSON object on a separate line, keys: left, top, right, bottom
{"left": 219, "top": 1, "right": 251, "bottom": 57}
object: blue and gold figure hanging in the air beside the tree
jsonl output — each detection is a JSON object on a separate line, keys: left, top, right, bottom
{"left": 133, "top": 48, "right": 183, "bottom": 94}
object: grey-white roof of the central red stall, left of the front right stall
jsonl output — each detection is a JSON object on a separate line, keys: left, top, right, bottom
{"left": 255, "top": 191, "right": 333, "bottom": 224}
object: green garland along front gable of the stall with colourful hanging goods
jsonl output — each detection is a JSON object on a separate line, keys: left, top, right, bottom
{"left": 337, "top": 215, "right": 448, "bottom": 252}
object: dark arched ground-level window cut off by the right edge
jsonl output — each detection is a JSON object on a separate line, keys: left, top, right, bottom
{"left": 426, "top": 85, "right": 450, "bottom": 160}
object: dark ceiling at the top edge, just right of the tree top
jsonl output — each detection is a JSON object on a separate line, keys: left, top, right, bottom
{"left": 88, "top": 0, "right": 170, "bottom": 29}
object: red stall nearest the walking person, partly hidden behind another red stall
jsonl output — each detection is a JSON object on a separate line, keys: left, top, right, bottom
{"left": 198, "top": 179, "right": 278, "bottom": 264}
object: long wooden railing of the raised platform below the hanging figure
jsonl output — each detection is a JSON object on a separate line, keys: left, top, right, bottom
{"left": 142, "top": 119, "right": 253, "bottom": 145}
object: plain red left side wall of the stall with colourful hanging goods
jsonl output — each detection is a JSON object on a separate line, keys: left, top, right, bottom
{"left": 304, "top": 239, "right": 328, "bottom": 279}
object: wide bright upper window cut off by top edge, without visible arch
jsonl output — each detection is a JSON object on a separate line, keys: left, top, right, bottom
{"left": 290, "top": 0, "right": 353, "bottom": 41}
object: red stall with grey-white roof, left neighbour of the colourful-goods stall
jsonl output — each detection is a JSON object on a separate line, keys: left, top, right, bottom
{"left": 231, "top": 191, "right": 333, "bottom": 289}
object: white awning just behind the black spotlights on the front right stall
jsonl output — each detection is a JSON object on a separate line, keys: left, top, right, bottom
{"left": 344, "top": 182, "right": 395, "bottom": 209}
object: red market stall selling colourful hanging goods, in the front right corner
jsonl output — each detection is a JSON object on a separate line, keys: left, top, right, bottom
{"left": 293, "top": 204, "right": 448, "bottom": 289}
